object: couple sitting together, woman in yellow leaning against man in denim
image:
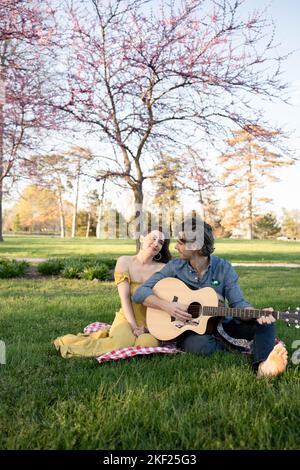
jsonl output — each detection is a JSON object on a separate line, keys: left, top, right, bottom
{"left": 54, "top": 218, "right": 288, "bottom": 377}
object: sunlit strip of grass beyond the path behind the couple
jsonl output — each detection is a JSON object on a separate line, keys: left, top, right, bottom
{"left": 0, "top": 236, "right": 300, "bottom": 263}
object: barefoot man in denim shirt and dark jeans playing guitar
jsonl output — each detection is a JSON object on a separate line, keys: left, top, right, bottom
{"left": 132, "top": 218, "right": 287, "bottom": 377}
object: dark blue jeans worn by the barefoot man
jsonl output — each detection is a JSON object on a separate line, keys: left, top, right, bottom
{"left": 177, "top": 318, "right": 275, "bottom": 369}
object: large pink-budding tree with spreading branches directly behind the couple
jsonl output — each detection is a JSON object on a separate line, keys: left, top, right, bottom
{"left": 56, "top": 0, "right": 290, "bottom": 242}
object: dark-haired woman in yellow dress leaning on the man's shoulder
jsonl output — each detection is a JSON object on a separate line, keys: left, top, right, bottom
{"left": 54, "top": 230, "right": 171, "bottom": 357}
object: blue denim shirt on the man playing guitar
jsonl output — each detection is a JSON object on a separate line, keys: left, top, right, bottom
{"left": 132, "top": 256, "right": 251, "bottom": 310}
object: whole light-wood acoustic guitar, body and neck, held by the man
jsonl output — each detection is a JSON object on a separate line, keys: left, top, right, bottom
{"left": 146, "top": 277, "right": 300, "bottom": 340}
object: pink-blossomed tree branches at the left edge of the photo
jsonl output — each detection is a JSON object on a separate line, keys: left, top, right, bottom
{"left": 0, "top": 0, "right": 54, "bottom": 241}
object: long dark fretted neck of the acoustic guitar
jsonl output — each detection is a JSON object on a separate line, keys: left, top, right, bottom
{"left": 201, "top": 307, "right": 289, "bottom": 320}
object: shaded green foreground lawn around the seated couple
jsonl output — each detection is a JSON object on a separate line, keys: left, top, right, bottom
{"left": 0, "top": 268, "right": 300, "bottom": 450}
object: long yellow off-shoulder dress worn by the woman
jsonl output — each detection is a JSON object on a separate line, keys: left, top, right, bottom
{"left": 54, "top": 272, "right": 159, "bottom": 358}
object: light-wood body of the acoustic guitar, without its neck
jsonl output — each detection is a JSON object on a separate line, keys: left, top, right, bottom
{"left": 147, "top": 277, "right": 219, "bottom": 340}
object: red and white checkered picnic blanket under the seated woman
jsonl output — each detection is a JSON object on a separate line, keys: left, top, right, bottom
{"left": 83, "top": 322, "right": 182, "bottom": 364}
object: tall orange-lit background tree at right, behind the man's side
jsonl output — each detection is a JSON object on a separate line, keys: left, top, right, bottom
{"left": 219, "top": 126, "right": 293, "bottom": 239}
